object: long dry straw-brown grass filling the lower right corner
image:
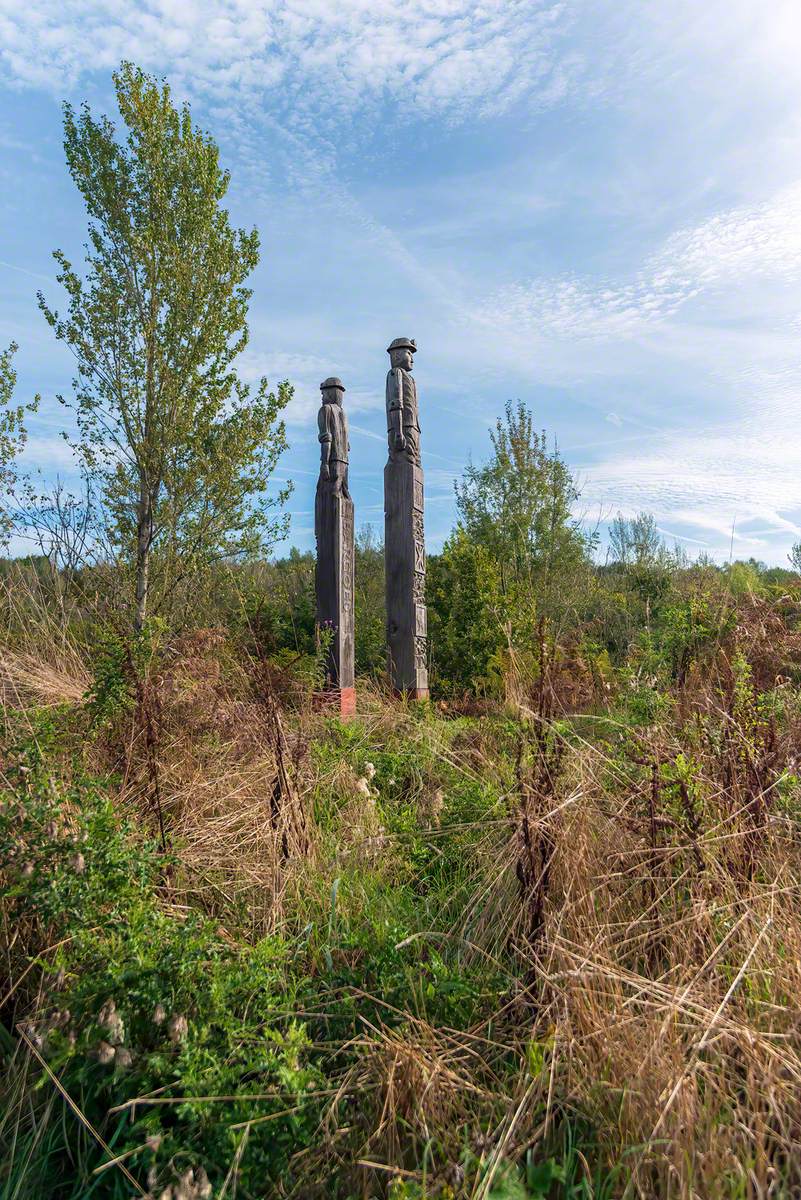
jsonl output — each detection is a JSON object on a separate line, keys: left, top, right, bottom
{"left": 434, "top": 655, "right": 801, "bottom": 1200}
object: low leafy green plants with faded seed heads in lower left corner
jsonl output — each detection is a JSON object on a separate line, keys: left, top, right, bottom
{"left": 0, "top": 746, "right": 324, "bottom": 1200}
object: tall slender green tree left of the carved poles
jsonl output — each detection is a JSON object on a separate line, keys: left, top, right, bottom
{"left": 40, "top": 62, "right": 291, "bottom": 629}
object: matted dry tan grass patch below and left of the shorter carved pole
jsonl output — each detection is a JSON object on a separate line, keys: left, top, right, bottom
{"left": 104, "top": 630, "right": 314, "bottom": 938}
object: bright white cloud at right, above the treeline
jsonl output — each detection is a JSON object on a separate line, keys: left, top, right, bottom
{"left": 460, "top": 182, "right": 801, "bottom": 562}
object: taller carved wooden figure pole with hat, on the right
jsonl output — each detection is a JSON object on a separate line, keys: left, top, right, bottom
{"left": 384, "top": 337, "right": 428, "bottom": 700}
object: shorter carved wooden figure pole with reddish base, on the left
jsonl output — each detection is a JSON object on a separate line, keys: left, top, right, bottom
{"left": 314, "top": 378, "right": 356, "bottom": 716}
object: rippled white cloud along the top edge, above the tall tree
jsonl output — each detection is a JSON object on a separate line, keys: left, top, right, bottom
{"left": 0, "top": 0, "right": 580, "bottom": 131}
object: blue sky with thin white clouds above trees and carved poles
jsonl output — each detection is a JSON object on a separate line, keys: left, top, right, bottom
{"left": 0, "top": 0, "right": 801, "bottom": 563}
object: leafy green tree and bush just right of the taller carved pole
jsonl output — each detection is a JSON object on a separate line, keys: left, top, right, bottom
{"left": 428, "top": 403, "right": 594, "bottom": 694}
